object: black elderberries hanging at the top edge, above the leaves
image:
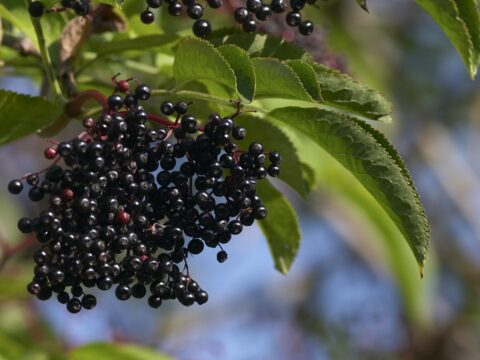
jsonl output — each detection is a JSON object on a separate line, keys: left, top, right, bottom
{"left": 140, "top": 0, "right": 316, "bottom": 37}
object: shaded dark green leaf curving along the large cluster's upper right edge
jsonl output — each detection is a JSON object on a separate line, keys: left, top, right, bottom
{"left": 235, "top": 115, "right": 311, "bottom": 197}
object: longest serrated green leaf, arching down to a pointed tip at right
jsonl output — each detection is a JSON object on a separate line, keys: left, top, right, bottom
{"left": 269, "top": 108, "right": 430, "bottom": 271}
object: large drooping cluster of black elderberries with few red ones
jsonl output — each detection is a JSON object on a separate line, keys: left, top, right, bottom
{"left": 8, "top": 80, "right": 281, "bottom": 313}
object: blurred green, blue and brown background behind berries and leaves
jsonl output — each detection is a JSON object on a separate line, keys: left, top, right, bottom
{"left": 0, "top": 0, "right": 480, "bottom": 360}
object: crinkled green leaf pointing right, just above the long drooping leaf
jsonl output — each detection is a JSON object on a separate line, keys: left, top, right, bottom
{"left": 311, "top": 63, "right": 392, "bottom": 122}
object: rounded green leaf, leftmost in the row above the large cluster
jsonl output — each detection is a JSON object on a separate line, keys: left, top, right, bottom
{"left": 173, "top": 38, "right": 237, "bottom": 95}
